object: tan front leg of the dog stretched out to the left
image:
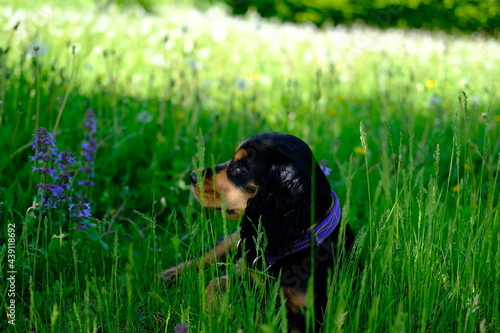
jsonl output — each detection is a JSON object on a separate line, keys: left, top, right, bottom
{"left": 161, "top": 232, "right": 240, "bottom": 281}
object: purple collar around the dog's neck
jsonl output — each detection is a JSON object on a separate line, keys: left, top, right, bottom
{"left": 266, "top": 191, "right": 342, "bottom": 266}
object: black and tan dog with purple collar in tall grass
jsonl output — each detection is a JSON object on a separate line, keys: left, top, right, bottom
{"left": 162, "top": 133, "right": 354, "bottom": 332}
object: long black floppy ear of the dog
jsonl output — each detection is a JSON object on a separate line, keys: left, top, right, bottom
{"left": 241, "top": 161, "right": 331, "bottom": 254}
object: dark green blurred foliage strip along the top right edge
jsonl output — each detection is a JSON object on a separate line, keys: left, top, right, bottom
{"left": 225, "top": 0, "right": 500, "bottom": 33}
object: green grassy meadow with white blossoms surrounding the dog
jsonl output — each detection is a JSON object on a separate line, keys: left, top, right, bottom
{"left": 0, "top": 2, "right": 500, "bottom": 332}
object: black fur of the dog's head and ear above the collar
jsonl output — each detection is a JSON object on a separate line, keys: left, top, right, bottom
{"left": 240, "top": 133, "right": 332, "bottom": 255}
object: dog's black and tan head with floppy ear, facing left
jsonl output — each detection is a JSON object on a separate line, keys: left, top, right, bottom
{"left": 191, "top": 133, "right": 332, "bottom": 253}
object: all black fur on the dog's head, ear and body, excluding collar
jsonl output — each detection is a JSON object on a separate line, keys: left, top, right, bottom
{"left": 230, "top": 133, "right": 354, "bottom": 332}
